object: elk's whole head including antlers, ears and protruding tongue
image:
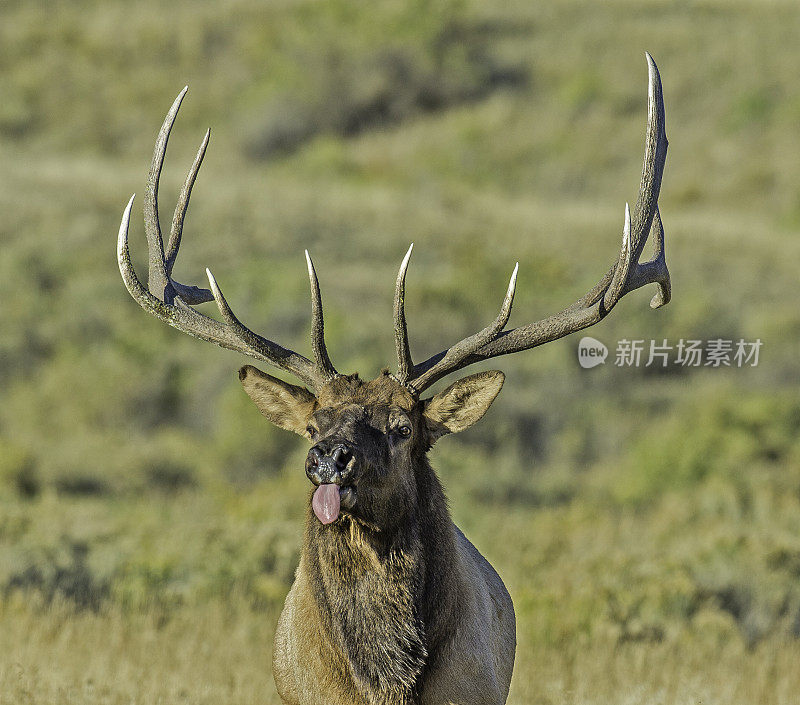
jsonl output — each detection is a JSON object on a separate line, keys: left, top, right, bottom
{"left": 117, "top": 54, "right": 670, "bottom": 529}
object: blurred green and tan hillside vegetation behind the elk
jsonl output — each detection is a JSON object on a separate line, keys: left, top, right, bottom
{"left": 0, "top": 0, "right": 800, "bottom": 704}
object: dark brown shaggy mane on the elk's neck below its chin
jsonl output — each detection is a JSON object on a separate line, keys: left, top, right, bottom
{"left": 303, "top": 457, "right": 460, "bottom": 705}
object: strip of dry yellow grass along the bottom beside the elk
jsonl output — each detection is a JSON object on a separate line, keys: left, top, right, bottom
{"left": 6, "top": 599, "right": 800, "bottom": 705}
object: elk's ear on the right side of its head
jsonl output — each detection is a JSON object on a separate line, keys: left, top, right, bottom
{"left": 422, "top": 370, "right": 506, "bottom": 445}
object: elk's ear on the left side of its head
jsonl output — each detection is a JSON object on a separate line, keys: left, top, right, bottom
{"left": 239, "top": 365, "right": 317, "bottom": 436}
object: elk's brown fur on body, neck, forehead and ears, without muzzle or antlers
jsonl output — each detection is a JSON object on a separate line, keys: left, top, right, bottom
{"left": 240, "top": 366, "right": 515, "bottom": 705}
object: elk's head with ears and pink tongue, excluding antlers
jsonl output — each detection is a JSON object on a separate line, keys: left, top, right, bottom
{"left": 239, "top": 365, "right": 503, "bottom": 531}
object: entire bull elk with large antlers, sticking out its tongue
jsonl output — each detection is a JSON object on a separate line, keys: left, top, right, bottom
{"left": 117, "top": 54, "right": 670, "bottom": 705}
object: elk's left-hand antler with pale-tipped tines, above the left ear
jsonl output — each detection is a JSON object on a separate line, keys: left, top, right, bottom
{"left": 117, "top": 87, "right": 338, "bottom": 388}
